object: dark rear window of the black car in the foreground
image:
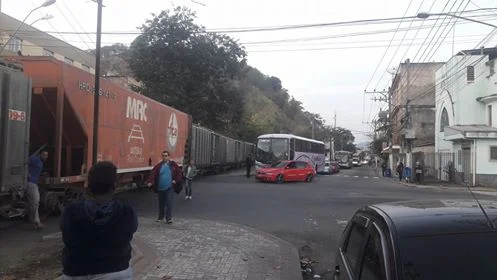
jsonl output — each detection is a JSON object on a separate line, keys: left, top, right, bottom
{"left": 399, "top": 232, "right": 497, "bottom": 280}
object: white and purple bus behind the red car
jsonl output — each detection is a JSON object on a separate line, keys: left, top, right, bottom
{"left": 255, "top": 134, "right": 325, "bottom": 172}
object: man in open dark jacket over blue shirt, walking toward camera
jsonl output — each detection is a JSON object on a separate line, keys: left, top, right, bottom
{"left": 147, "top": 151, "right": 183, "bottom": 224}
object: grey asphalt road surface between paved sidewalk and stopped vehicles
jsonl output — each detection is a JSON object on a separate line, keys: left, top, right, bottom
{"left": 117, "top": 166, "right": 492, "bottom": 279}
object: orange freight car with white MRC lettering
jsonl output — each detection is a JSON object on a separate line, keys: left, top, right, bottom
{"left": 16, "top": 57, "right": 191, "bottom": 184}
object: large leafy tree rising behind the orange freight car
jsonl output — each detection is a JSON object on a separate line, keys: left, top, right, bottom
{"left": 127, "top": 7, "right": 246, "bottom": 132}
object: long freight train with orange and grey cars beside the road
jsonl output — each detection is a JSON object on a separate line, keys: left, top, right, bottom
{"left": 0, "top": 57, "right": 255, "bottom": 218}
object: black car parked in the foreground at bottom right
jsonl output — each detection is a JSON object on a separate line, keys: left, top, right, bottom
{"left": 334, "top": 200, "right": 497, "bottom": 280}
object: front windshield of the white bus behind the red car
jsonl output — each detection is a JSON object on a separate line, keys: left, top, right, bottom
{"left": 255, "top": 138, "right": 289, "bottom": 164}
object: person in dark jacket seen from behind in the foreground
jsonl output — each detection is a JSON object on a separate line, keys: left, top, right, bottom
{"left": 60, "top": 161, "right": 138, "bottom": 280}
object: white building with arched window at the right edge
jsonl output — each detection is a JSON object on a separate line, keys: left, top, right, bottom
{"left": 435, "top": 48, "right": 497, "bottom": 187}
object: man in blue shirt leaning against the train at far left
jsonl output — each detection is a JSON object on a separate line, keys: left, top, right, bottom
{"left": 26, "top": 151, "right": 48, "bottom": 229}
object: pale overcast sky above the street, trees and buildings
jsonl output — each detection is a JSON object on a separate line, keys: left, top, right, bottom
{"left": 1, "top": 0, "right": 497, "bottom": 142}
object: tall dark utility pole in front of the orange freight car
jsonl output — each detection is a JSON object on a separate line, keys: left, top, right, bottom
{"left": 92, "top": 0, "right": 103, "bottom": 165}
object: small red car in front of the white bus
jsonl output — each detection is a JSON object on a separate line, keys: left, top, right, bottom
{"left": 255, "top": 160, "right": 316, "bottom": 184}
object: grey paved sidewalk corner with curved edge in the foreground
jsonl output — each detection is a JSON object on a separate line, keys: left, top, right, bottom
{"left": 131, "top": 218, "right": 302, "bottom": 280}
